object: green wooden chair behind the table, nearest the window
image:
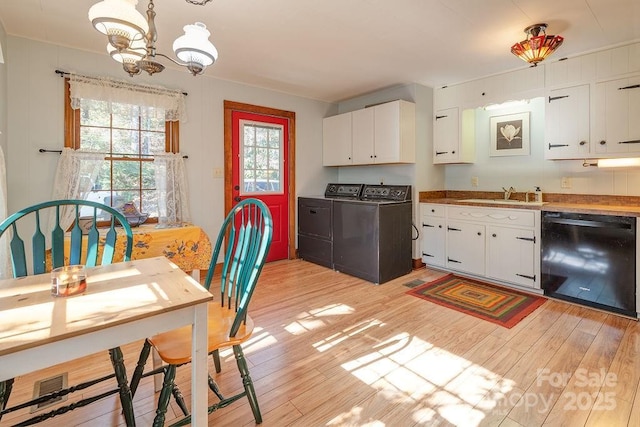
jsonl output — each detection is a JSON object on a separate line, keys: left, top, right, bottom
{"left": 0, "top": 200, "right": 135, "bottom": 426}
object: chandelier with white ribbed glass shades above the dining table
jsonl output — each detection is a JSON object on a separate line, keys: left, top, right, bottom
{"left": 89, "top": 0, "right": 218, "bottom": 77}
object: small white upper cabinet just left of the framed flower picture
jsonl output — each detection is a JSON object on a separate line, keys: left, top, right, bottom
{"left": 433, "top": 107, "right": 475, "bottom": 164}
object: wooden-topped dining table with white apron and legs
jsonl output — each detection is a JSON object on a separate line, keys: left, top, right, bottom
{"left": 0, "top": 256, "right": 213, "bottom": 426}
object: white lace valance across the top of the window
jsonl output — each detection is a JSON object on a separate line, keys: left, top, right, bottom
{"left": 69, "top": 74, "right": 187, "bottom": 122}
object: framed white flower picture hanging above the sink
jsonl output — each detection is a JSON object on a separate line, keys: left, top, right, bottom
{"left": 489, "top": 111, "right": 530, "bottom": 157}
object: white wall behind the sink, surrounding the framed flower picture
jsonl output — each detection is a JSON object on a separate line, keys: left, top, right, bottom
{"left": 445, "top": 98, "right": 640, "bottom": 196}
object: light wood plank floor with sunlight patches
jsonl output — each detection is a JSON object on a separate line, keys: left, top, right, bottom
{"left": 0, "top": 260, "right": 640, "bottom": 427}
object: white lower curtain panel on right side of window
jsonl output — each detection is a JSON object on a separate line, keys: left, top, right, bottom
{"left": 153, "top": 153, "right": 191, "bottom": 228}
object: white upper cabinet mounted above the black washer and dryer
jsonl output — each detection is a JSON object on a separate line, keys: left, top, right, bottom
{"left": 322, "top": 100, "right": 416, "bottom": 166}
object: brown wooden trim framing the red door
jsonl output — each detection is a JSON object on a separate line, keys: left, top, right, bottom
{"left": 224, "top": 100, "right": 296, "bottom": 259}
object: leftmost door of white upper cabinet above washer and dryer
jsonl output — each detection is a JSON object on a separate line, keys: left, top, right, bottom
{"left": 322, "top": 113, "right": 352, "bottom": 166}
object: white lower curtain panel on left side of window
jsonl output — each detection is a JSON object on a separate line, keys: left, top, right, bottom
{"left": 48, "top": 147, "right": 104, "bottom": 236}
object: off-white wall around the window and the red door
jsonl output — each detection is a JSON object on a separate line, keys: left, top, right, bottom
{"left": 5, "top": 37, "right": 337, "bottom": 247}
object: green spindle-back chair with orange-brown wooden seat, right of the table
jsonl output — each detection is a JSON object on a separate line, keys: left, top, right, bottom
{"left": 131, "top": 199, "right": 273, "bottom": 427}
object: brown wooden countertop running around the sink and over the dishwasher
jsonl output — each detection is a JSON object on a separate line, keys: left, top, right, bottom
{"left": 419, "top": 191, "right": 640, "bottom": 217}
